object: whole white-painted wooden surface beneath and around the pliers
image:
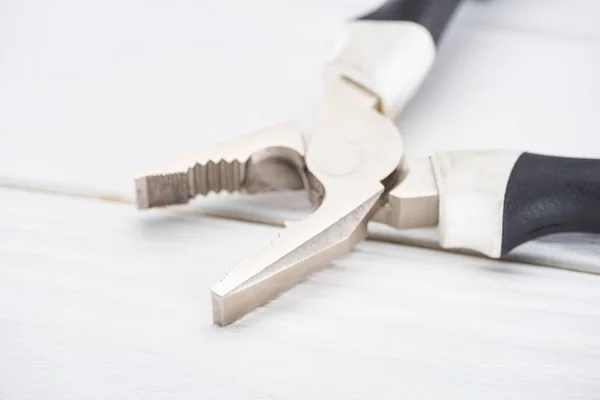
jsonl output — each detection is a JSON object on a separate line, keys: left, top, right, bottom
{"left": 0, "top": 0, "right": 600, "bottom": 399}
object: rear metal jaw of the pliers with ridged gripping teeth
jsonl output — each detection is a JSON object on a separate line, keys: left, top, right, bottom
{"left": 135, "top": 122, "right": 308, "bottom": 209}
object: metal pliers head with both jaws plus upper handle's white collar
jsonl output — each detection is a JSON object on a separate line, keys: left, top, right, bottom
{"left": 135, "top": 21, "right": 435, "bottom": 325}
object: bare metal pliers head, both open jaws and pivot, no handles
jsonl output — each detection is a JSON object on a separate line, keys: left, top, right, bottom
{"left": 135, "top": 79, "right": 403, "bottom": 325}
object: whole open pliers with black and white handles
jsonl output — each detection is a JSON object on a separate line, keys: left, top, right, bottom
{"left": 135, "top": 0, "right": 600, "bottom": 325}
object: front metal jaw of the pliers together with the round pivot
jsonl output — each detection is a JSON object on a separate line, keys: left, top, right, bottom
{"left": 212, "top": 80, "right": 402, "bottom": 326}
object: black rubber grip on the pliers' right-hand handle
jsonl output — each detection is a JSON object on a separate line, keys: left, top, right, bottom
{"left": 502, "top": 153, "right": 600, "bottom": 254}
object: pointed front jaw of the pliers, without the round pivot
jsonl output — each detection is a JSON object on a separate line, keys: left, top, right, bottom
{"left": 211, "top": 182, "right": 385, "bottom": 326}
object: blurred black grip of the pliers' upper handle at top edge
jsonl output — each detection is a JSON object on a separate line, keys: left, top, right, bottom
{"left": 358, "top": 0, "right": 461, "bottom": 44}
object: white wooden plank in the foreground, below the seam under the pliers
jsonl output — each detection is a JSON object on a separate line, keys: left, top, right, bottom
{"left": 0, "top": 190, "right": 600, "bottom": 400}
